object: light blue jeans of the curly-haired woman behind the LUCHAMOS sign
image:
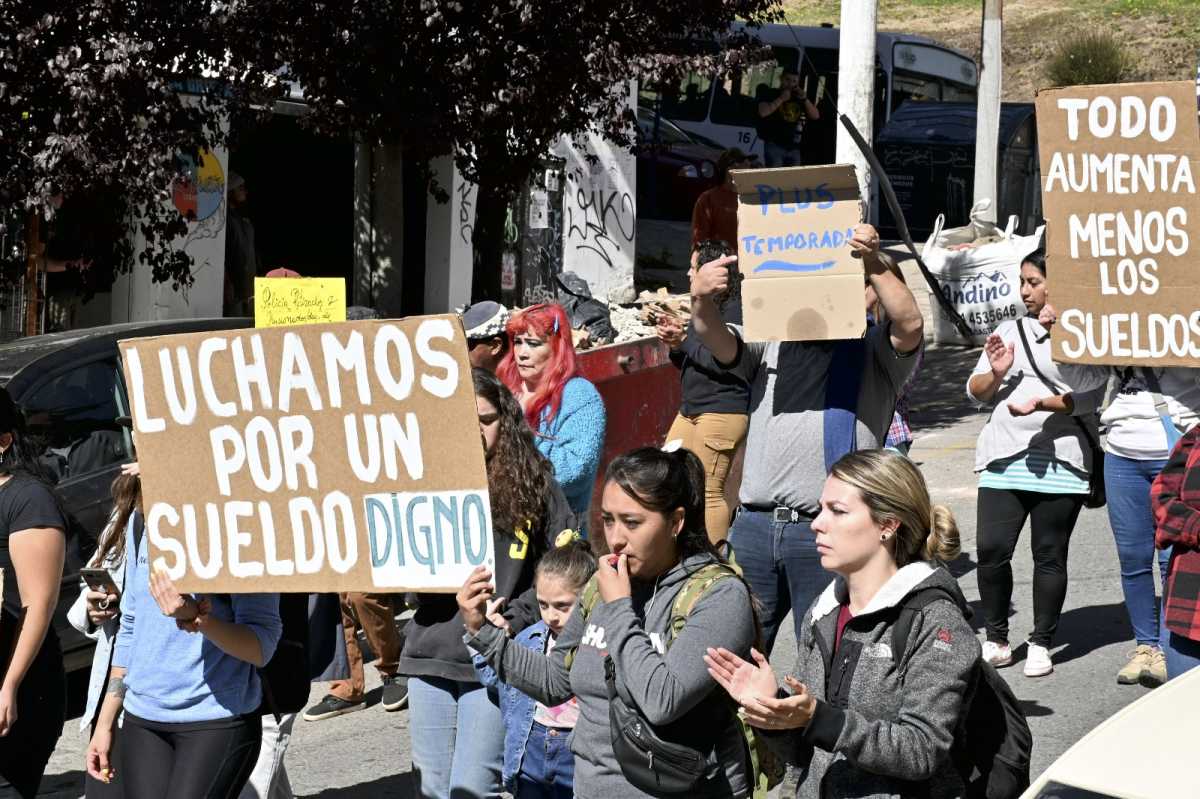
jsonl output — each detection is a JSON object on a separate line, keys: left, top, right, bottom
{"left": 408, "top": 677, "right": 504, "bottom": 799}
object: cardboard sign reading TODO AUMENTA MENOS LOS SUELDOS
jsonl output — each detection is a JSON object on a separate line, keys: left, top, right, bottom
{"left": 1037, "top": 82, "right": 1200, "bottom": 366}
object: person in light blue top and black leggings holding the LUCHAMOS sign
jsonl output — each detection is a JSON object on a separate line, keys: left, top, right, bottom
{"left": 86, "top": 494, "right": 283, "bottom": 799}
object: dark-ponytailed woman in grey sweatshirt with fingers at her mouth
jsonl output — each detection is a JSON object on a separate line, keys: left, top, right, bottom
{"left": 458, "top": 447, "right": 758, "bottom": 799}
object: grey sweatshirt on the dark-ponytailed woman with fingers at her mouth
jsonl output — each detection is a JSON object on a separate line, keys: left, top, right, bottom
{"left": 464, "top": 555, "right": 754, "bottom": 799}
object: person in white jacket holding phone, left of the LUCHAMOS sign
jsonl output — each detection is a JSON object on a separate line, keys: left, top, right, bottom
{"left": 67, "top": 463, "right": 142, "bottom": 799}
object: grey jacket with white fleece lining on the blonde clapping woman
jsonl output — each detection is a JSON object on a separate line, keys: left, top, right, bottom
{"left": 767, "top": 563, "right": 979, "bottom": 799}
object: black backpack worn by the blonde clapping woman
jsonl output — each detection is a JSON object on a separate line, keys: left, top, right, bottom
{"left": 892, "top": 588, "right": 1033, "bottom": 799}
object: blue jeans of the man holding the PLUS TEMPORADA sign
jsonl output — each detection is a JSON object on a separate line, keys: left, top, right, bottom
{"left": 730, "top": 507, "right": 833, "bottom": 655}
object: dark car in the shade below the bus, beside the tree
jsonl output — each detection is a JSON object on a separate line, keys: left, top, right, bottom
{"left": 637, "top": 107, "right": 721, "bottom": 221}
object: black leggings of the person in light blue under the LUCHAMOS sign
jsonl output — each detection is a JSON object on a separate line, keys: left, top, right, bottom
{"left": 116, "top": 713, "right": 263, "bottom": 799}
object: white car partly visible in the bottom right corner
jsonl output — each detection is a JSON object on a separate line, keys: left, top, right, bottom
{"left": 1021, "top": 668, "right": 1200, "bottom": 799}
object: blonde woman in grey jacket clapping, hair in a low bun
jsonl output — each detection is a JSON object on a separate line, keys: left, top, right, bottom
{"left": 706, "top": 450, "right": 980, "bottom": 799}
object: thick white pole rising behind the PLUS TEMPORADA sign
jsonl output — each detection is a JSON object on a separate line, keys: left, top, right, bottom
{"left": 836, "top": 0, "right": 878, "bottom": 209}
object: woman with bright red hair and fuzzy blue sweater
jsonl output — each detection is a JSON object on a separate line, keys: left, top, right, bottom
{"left": 496, "top": 305, "right": 605, "bottom": 527}
